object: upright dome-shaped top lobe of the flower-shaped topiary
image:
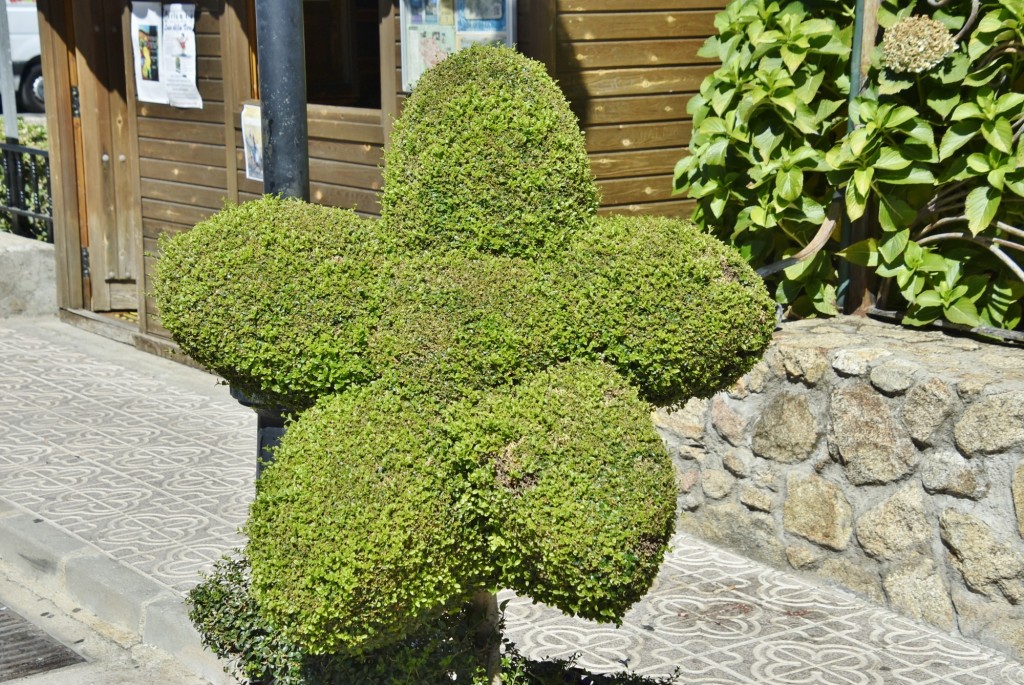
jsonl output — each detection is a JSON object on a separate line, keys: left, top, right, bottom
{"left": 381, "top": 46, "right": 597, "bottom": 256}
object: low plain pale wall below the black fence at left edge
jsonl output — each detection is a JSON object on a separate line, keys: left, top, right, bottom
{"left": 0, "top": 231, "right": 57, "bottom": 318}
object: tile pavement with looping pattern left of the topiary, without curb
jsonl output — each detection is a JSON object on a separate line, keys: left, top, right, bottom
{"left": 0, "top": 322, "right": 256, "bottom": 592}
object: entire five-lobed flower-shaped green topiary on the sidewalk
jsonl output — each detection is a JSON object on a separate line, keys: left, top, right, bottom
{"left": 172, "top": 47, "right": 774, "bottom": 682}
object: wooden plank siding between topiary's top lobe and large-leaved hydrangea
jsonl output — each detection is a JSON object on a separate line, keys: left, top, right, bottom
{"left": 554, "top": 0, "right": 725, "bottom": 216}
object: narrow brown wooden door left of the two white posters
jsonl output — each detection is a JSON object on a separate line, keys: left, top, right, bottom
{"left": 66, "top": 0, "right": 140, "bottom": 311}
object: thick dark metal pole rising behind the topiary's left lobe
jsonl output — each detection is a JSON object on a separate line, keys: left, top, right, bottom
{"left": 256, "top": 0, "right": 309, "bottom": 201}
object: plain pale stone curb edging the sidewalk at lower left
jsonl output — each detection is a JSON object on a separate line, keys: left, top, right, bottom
{"left": 0, "top": 498, "right": 236, "bottom": 685}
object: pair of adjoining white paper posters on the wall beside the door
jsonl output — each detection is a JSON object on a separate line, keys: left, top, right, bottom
{"left": 131, "top": 2, "right": 203, "bottom": 109}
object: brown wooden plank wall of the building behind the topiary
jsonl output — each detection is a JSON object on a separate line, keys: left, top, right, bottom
{"left": 56, "top": 0, "right": 726, "bottom": 338}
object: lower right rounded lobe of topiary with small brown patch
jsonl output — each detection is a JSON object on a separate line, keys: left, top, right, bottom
{"left": 456, "top": 362, "right": 676, "bottom": 622}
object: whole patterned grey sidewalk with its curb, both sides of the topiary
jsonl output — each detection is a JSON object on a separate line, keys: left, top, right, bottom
{"left": 0, "top": 318, "right": 1024, "bottom": 685}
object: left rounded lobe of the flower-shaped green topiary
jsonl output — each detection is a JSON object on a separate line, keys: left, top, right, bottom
{"left": 154, "top": 196, "right": 386, "bottom": 409}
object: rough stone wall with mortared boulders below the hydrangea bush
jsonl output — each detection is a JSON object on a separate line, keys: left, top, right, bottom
{"left": 654, "top": 317, "right": 1024, "bottom": 658}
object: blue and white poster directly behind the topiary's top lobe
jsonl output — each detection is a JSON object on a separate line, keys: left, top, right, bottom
{"left": 400, "top": 0, "right": 515, "bottom": 92}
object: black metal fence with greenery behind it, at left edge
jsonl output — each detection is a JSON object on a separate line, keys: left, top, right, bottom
{"left": 0, "top": 142, "right": 53, "bottom": 243}
